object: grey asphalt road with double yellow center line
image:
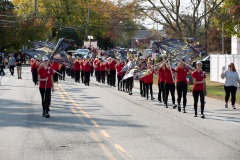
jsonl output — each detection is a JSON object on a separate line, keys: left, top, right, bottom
{"left": 0, "top": 67, "right": 240, "bottom": 160}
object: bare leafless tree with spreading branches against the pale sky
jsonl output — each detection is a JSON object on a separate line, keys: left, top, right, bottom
{"left": 137, "top": 0, "right": 224, "bottom": 43}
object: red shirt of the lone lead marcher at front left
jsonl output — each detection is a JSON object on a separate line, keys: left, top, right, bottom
{"left": 38, "top": 66, "right": 54, "bottom": 88}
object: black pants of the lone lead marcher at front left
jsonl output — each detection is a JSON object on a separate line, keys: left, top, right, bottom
{"left": 39, "top": 88, "right": 51, "bottom": 114}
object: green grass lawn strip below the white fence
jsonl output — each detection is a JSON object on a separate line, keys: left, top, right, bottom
{"left": 154, "top": 74, "right": 240, "bottom": 104}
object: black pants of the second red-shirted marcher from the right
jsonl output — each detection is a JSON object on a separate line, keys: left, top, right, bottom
{"left": 177, "top": 82, "right": 187, "bottom": 108}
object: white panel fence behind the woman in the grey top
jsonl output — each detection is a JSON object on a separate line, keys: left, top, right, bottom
{"left": 210, "top": 54, "right": 240, "bottom": 83}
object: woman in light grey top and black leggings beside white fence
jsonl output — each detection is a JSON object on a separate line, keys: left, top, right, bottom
{"left": 221, "top": 63, "right": 240, "bottom": 109}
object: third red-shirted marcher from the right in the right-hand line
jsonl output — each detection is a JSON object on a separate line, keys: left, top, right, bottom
{"left": 164, "top": 62, "right": 177, "bottom": 109}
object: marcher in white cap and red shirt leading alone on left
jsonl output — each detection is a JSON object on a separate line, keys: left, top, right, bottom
{"left": 38, "top": 57, "right": 54, "bottom": 118}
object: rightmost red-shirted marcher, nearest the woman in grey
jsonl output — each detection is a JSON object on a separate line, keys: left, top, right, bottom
{"left": 192, "top": 61, "right": 206, "bottom": 118}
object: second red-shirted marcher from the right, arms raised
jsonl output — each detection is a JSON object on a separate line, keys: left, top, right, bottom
{"left": 175, "top": 61, "right": 190, "bottom": 113}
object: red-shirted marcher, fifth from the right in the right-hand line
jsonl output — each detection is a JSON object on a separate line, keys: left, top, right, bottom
{"left": 144, "top": 62, "right": 155, "bottom": 100}
